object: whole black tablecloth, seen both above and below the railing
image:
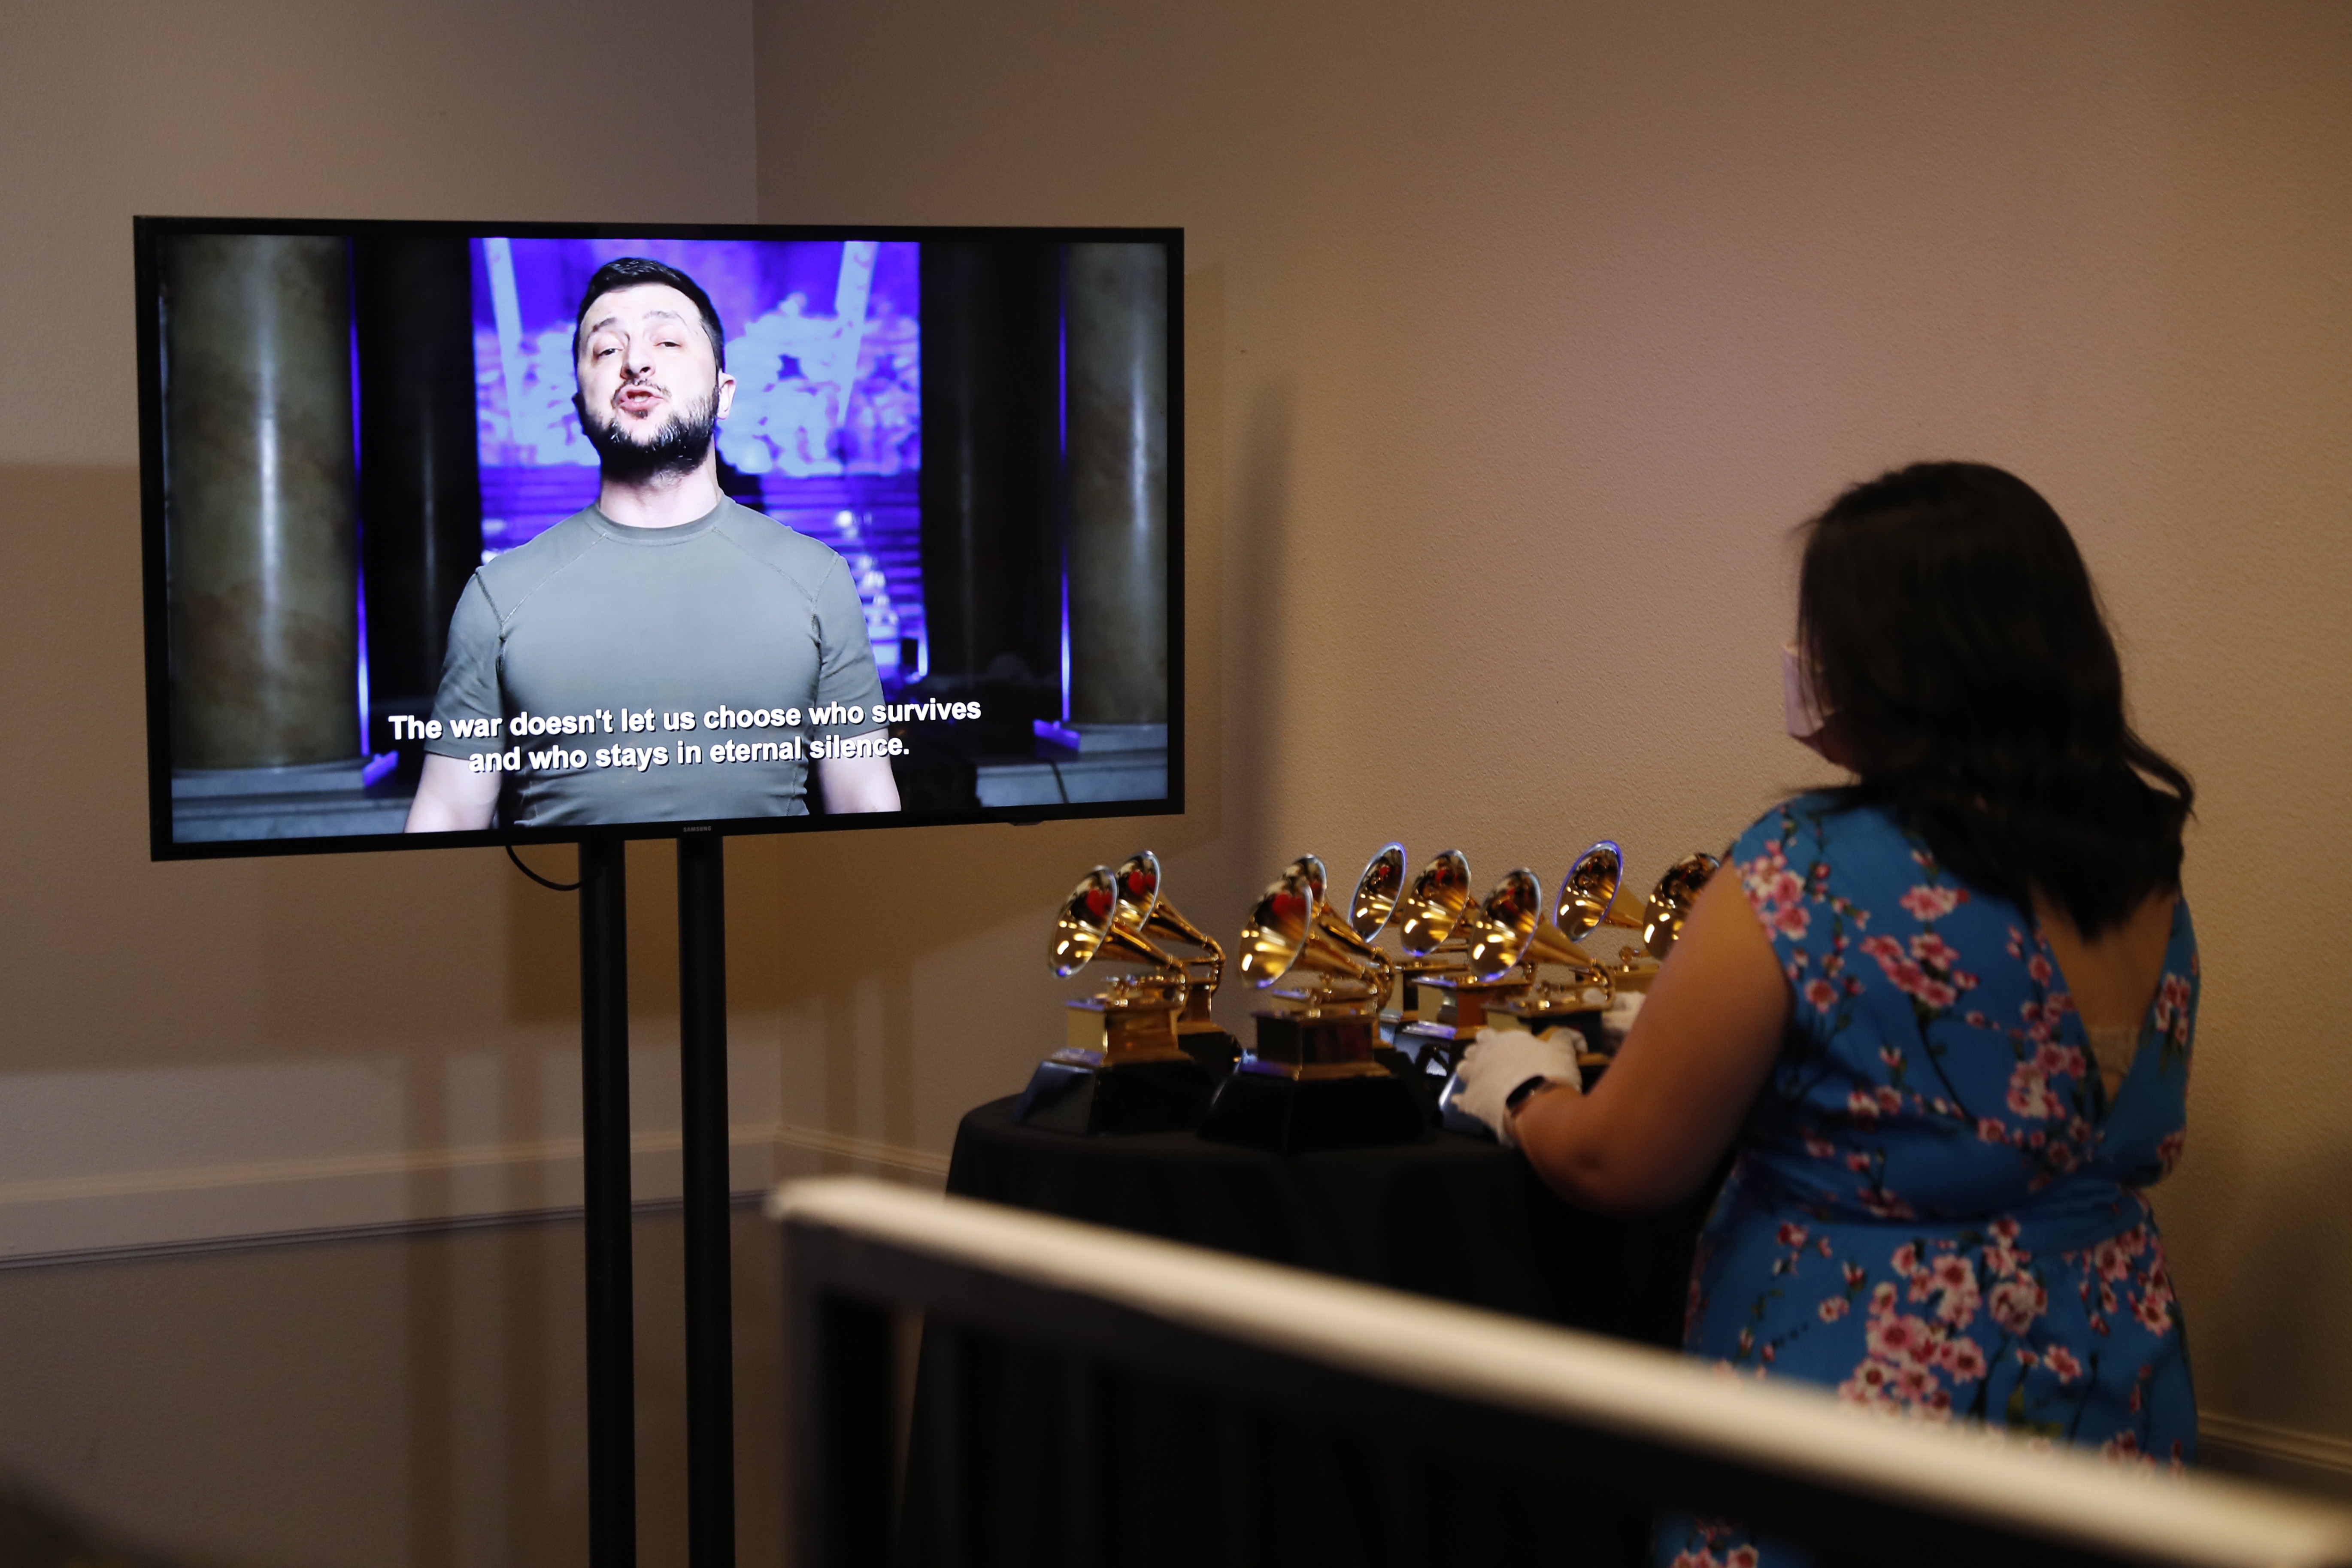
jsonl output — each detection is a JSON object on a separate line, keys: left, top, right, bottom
{"left": 898, "top": 1100, "right": 1705, "bottom": 1568}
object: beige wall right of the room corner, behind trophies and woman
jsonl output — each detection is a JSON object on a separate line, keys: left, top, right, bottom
{"left": 760, "top": 0, "right": 2352, "bottom": 1460}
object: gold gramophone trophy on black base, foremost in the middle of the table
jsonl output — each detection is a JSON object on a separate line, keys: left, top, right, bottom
{"left": 1200, "top": 856, "right": 1428, "bottom": 1154}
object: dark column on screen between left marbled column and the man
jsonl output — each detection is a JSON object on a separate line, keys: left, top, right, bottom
{"left": 351, "top": 230, "right": 482, "bottom": 752}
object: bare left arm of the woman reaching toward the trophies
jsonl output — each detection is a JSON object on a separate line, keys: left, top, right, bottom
{"left": 1512, "top": 867, "right": 1790, "bottom": 1213}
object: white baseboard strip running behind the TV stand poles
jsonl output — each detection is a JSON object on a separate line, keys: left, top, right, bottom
{"left": 0, "top": 1121, "right": 948, "bottom": 1267}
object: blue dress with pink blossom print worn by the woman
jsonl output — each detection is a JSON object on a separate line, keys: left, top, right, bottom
{"left": 1658, "top": 795, "right": 2197, "bottom": 1568}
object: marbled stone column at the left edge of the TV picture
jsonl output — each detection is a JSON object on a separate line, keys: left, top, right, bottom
{"left": 165, "top": 235, "right": 360, "bottom": 769}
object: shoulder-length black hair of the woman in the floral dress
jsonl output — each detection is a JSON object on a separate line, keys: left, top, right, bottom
{"left": 1797, "top": 463, "right": 2197, "bottom": 938}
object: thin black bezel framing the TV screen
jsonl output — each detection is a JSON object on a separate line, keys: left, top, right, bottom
{"left": 132, "top": 216, "right": 1185, "bottom": 860}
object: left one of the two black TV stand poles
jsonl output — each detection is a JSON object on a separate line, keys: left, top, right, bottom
{"left": 579, "top": 839, "right": 637, "bottom": 1568}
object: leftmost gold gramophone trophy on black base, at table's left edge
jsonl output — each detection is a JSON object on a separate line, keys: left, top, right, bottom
{"left": 1014, "top": 856, "right": 1223, "bottom": 1133}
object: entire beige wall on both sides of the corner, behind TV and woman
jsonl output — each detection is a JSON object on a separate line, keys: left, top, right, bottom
{"left": 0, "top": 0, "right": 2352, "bottom": 1561}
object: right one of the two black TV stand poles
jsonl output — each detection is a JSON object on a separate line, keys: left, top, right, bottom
{"left": 677, "top": 832, "right": 734, "bottom": 1568}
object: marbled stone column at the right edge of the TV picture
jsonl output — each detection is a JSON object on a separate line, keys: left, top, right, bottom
{"left": 1065, "top": 245, "right": 1169, "bottom": 726}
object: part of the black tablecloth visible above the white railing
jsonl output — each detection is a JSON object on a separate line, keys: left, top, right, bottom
{"left": 948, "top": 1098, "right": 1712, "bottom": 1347}
